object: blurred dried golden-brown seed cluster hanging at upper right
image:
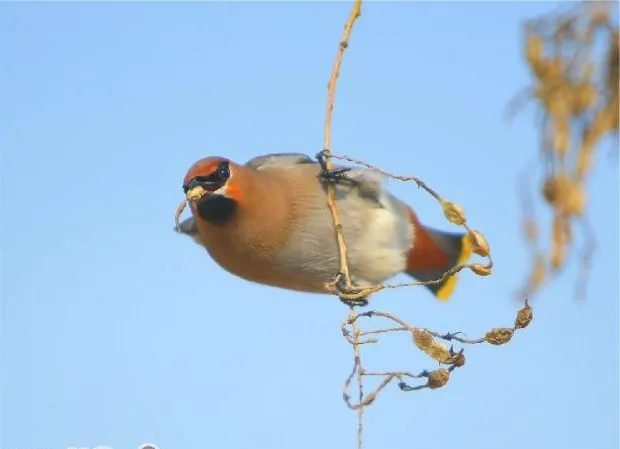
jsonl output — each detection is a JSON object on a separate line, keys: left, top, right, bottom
{"left": 510, "top": 2, "right": 619, "bottom": 299}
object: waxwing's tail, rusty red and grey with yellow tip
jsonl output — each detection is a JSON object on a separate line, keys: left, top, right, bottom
{"left": 406, "top": 220, "right": 472, "bottom": 301}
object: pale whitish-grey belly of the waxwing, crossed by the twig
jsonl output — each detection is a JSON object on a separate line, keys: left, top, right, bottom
{"left": 278, "top": 184, "right": 413, "bottom": 287}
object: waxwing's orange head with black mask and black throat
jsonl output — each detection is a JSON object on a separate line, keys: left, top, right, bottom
{"left": 183, "top": 156, "right": 242, "bottom": 224}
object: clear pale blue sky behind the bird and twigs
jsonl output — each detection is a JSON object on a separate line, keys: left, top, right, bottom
{"left": 0, "top": 2, "right": 618, "bottom": 449}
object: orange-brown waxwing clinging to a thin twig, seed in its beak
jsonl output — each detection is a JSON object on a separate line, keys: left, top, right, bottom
{"left": 177, "top": 153, "right": 471, "bottom": 300}
